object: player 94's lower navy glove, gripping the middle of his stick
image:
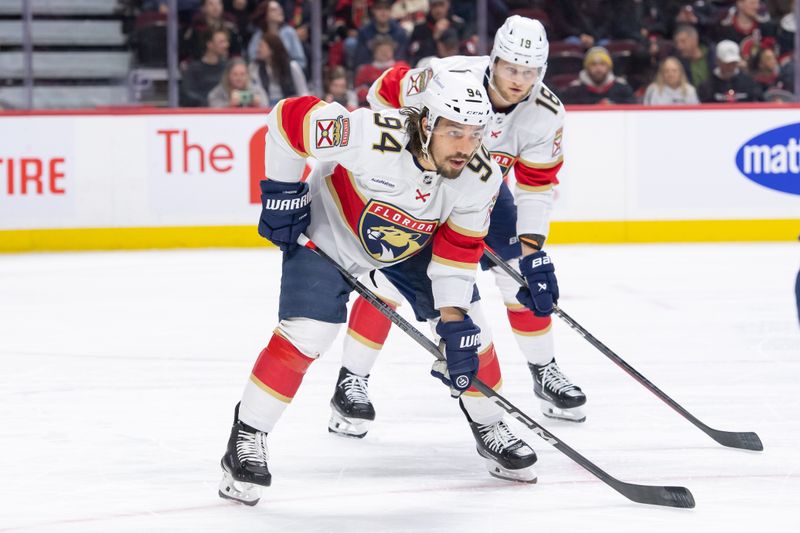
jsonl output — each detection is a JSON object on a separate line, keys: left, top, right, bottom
{"left": 431, "top": 315, "right": 481, "bottom": 398}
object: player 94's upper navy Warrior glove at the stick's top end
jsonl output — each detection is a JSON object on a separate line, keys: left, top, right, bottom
{"left": 258, "top": 180, "right": 311, "bottom": 251}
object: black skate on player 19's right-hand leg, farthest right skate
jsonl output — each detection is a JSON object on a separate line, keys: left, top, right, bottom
{"left": 528, "top": 358, "right": 586, "bottom": 422}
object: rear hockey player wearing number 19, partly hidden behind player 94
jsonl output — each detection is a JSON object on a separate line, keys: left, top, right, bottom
{"left": 329, "top": 15, "right": 586, "bottom": 437}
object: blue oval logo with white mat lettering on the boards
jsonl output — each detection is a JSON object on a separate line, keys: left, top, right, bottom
{"left": 736, "top": 124, "right": 800, "bottom": 194}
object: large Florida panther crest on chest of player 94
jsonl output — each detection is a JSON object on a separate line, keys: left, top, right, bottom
{"left": 358, "top": 200, "right": 439, "bottom": 263}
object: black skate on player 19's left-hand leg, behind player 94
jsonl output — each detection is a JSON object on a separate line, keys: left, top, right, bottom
{"left": 328, "top": 367, "right": 375, "bottom": 439}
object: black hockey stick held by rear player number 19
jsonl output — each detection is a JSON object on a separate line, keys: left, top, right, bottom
{"left": 483, "top": 246, "right": 764, "bottom": 451}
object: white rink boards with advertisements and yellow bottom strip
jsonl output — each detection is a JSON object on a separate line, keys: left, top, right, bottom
{"left": 0, "top": 105, "right": 800, "bottom": 251}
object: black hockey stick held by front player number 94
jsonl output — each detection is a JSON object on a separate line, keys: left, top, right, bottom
{"left": 297, "top": 235, "right": 694, "bottom": 508}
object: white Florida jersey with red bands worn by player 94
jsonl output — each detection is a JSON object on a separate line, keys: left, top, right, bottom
{"left": 265, "top": 96, "right": 502, "bottom": 309}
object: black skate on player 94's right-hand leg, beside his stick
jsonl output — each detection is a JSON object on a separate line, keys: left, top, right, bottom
{"left": 458, "top": 400, "right": 537, "bottom": 483}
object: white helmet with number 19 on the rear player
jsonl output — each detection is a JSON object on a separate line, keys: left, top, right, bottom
{"left": 489, "top": 15, "right": 550, "bottom": 83}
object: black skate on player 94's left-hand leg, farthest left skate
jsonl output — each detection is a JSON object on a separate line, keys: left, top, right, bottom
{"left": 219, "top": 404, "right": 272, "bottom": 505}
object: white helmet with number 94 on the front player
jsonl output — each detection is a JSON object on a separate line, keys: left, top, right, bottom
{"left": 422, "top": 70, "right": 492, "bottom": 152}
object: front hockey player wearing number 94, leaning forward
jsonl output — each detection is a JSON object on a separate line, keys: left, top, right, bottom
{"left": 219, "top": 71, "right": 536, "bottom": 505}
